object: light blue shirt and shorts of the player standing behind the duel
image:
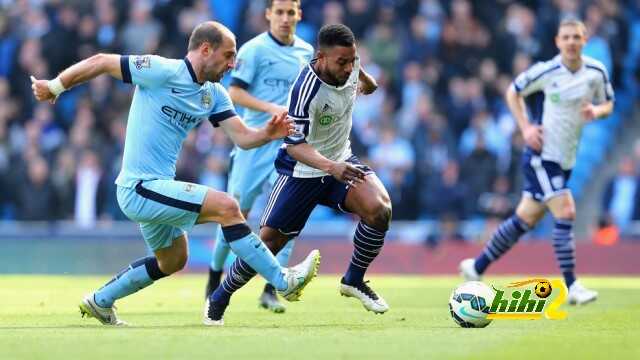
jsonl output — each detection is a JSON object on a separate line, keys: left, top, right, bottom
{"left": 228, "top": 32, "right": 313, "bottom": 211}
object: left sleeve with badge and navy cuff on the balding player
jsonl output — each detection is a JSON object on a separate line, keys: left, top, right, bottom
{"left": 120, "top": 55, "right": 177, "bottom": 88}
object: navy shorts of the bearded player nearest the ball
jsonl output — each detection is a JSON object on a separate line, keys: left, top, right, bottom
{"left": 260, "top": 156, "right": 373, "bottom": 237}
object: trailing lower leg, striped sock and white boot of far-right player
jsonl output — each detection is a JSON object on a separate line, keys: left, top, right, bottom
{"left": 460, "top": 196, "right": 547, "bottom": 281}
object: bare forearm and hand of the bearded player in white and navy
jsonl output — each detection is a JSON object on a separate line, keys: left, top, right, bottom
{"left": 287, "top": 142, "right": 366, "bottom": 187}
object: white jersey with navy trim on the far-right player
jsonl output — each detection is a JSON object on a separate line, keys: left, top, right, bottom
{"left": 512, "top": 55, "right": 614, "bottom": 170}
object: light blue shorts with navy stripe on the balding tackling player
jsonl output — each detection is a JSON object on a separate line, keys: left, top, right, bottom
{"left": 117, "top": 180, "right": 208, "bottom": 251}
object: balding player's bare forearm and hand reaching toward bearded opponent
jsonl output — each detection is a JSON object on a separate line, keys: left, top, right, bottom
{"left": 220, "top": 112, "right": 293, "bottom": 150}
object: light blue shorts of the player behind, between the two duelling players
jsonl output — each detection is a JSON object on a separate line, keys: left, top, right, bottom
{"left": 227, "top": 141, "right": 280, "bottom": 211}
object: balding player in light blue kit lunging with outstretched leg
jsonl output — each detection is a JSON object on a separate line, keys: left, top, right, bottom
{"left": 31, "top": 21, "right": 319, "bottom": 325}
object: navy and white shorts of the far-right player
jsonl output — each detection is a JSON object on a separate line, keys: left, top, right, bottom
{"left": 522, "top": 152, "right": 571, "bottom": 202}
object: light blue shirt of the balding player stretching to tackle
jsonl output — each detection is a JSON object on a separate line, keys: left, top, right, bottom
{"left": 116, "top": 55, "right": 236, "bottom": 188}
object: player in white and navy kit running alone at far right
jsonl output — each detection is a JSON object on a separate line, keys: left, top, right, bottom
{"left": 460, "top": 20, "right": 614, "bottom": 304}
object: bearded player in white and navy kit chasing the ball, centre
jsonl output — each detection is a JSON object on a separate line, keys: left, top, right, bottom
{"left": 208, "top": 24, "right": 391, "bottom": 320}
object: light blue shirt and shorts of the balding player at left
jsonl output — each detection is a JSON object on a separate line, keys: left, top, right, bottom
{"left": 116, "top": 55, "right": 236, "bottom": 251}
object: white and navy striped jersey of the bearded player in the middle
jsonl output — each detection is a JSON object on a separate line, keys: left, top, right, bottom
{"left": 275, "top": 58, "right": 360, "bottom": 178}
